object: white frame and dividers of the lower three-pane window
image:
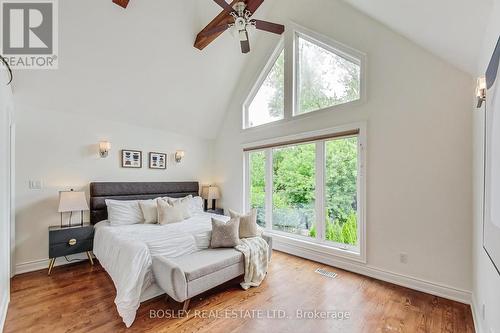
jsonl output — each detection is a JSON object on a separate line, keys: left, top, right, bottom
{"left": 242, "top": 123, "right": 367, "bottom": 263}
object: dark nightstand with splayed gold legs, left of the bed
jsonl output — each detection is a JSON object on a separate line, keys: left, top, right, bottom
{"left": 48, "top": 224, "right": 94, "bottom": 275}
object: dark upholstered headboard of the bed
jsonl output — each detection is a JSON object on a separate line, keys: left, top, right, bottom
{"left": 90, "top": 182, "right": 200, "bottom": 224}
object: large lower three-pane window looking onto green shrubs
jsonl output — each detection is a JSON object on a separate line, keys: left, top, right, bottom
{"left": 245, "top": 129, "right": 364, "bottom": 256}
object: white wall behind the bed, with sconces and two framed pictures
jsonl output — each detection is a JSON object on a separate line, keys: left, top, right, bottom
{"left": 15, "top": 105, "right": 213, "bottom": 273}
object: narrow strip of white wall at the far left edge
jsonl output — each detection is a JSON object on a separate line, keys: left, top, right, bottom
{"left": 0, "top": 66, "right": 13, "bottom": 331}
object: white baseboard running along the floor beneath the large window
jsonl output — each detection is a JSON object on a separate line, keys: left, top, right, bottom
{"left": 273, "top": 239, "right": 472, "bottom": 304}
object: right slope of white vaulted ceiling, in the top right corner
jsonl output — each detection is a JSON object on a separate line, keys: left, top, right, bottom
{"left": 344, "top": 0, "right": 494, "bottom": 74}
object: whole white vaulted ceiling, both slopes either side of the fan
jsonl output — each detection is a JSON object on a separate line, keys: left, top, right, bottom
{"left": 14, "top": 0, "right": 494, "bottom": 139}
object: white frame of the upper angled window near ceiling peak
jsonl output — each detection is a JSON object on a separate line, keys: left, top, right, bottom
{"left": 241, "top": 21, "right": 367, "bottom": 132}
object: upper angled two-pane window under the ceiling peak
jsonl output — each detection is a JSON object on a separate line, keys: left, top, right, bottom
{"left": 243, "top": 24, "right": 365, "bottom": 129}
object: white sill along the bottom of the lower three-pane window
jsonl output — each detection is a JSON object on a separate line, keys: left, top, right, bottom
{"left": 264, "top": 230, "right": 366, "bottom": 264}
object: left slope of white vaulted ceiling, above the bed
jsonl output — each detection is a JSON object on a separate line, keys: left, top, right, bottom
{"left": 14, "top": 0, "right": 266, "bottom": 138}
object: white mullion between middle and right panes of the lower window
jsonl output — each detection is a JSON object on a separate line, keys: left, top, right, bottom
{"left": 315, "top": 141, "right": 325, "bottom": 240}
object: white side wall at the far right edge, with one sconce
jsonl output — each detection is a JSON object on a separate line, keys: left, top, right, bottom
{"left": 473, "top": 1, "right": 500, "bottom": 333}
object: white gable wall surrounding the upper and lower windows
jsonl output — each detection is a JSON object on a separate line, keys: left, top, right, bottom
{"left": 215, "top": 0, "right": 473, "bottom": 300}
